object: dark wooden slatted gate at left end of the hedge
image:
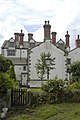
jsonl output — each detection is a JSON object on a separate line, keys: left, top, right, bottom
{"left": 11, "top": 89, "right": 27, "bottom": 107}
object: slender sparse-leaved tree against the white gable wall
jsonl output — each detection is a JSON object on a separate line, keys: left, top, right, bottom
{"left": 35, "top": 53, "right": 55, "bottom": 84}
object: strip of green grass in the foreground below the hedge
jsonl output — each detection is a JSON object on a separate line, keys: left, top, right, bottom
{"left": 7, "top": 103, "right": 80, "bottom": 120}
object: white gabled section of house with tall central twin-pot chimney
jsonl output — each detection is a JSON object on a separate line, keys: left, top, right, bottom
{"left": 29, "top": 21, "right": 67, "bottom": 87}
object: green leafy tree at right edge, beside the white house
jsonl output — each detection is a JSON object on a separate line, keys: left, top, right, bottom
{"left": 69, "top": 61, "right": 80, "bottom": 82}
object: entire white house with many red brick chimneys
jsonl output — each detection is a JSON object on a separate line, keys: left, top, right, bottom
{"left": 1, "top": 21, "right": 80, "bottom": 87}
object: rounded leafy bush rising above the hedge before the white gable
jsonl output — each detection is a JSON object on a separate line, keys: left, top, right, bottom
{"left": 42, "top": 77, "right": 65, "bottom": 103}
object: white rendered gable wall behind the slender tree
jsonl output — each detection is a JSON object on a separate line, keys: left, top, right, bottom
{"left": 30, "top": 40, "right": 65, "bottom": 80}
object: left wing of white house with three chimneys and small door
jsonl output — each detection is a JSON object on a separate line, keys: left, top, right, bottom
{"left": 1, "top": 30, "right": 39, "bottom": 85}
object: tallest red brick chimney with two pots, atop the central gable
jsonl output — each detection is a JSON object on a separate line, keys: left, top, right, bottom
{"left": 43, "top": 21, "right": 51, "bottom": 41}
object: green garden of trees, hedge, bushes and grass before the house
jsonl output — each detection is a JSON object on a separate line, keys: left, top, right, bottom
{"left": 0, "top": 56, "right": 80, "bottom": 120}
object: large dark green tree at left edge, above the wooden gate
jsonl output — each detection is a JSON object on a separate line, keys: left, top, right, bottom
{"left": 0, "top": 55, "right": 17, "bottom": 93}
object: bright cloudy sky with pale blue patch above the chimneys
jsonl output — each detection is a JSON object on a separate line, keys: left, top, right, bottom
{"left": 0, "top": 0, "right": 80, "bottom": 51}
